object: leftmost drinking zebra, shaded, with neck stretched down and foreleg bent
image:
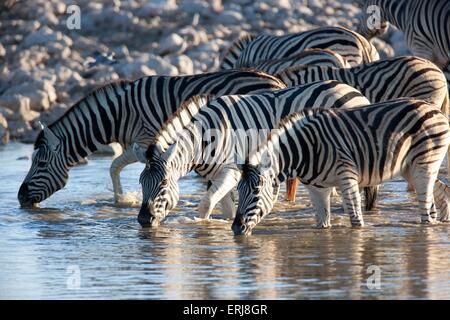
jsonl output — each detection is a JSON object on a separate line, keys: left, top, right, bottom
{"left": 18, "top": 70, "right": 286, "bottom": 206}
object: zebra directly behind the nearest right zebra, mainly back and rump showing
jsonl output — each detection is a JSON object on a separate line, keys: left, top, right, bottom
{"left": 275, "top": 56, "right": 450, "bottom": 211}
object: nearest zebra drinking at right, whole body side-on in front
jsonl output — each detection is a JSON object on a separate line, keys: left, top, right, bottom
{"left": 232, "top": 99, "right": 450, "bottom": 234}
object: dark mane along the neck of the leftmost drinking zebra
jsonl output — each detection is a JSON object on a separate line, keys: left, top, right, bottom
{"left": 34, "top": 80, "right": 134, "bottom": 149}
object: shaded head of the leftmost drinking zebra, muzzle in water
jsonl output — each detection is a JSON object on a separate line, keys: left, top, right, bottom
{"left": 17, "top": 124, "right": 69, "bottom": 207}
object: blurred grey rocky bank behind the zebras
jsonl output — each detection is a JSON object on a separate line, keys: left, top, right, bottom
{"left": 0, "top": 0, "right": 407, "bottom": 145}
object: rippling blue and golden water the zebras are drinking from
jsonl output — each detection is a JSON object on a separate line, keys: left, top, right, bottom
{"left": 0, "top": 144, "right": 450, "bottom": 299}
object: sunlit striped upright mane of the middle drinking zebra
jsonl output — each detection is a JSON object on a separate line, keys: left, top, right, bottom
{"left": 147, "top": 94, "right": 215, "bottom": 147}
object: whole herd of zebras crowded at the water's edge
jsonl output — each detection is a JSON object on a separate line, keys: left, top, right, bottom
{"left": 18, "top": 0, "right": 450, "bottom": 234}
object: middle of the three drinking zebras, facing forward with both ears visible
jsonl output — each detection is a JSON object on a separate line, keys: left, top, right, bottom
{"left": 134, "top": 81, "right": 369, "bottom": 226}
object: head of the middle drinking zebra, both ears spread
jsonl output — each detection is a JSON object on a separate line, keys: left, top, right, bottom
{"left": 133, "top": 143, "right": 179, "bottom": 227}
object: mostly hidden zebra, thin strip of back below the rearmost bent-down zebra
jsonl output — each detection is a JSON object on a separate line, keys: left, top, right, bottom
{"left": 252, "top": 49, "right": 351, "bottom": 75}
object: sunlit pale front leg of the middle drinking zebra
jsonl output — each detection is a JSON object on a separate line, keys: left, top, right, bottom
{"left": 198, "top": 168, "right": 241, "bottom": 219}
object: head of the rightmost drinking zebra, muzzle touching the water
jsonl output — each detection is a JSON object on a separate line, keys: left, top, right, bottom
{"left": 231, "top": 164, "right": 278, "bottom": 235}
